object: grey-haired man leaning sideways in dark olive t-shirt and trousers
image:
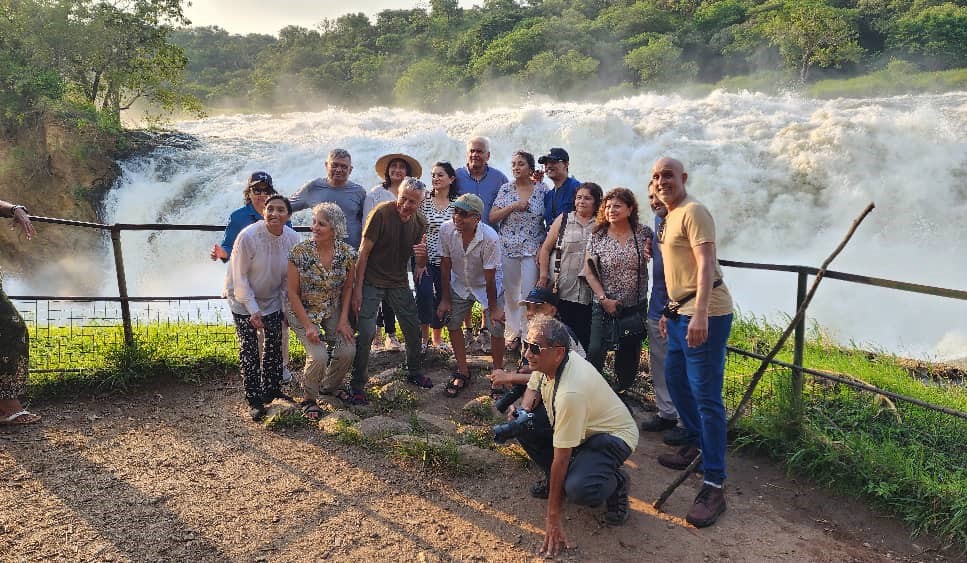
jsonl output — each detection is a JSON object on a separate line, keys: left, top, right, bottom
{"left": 349, "top": 178, "right": 433, "bottom": 404}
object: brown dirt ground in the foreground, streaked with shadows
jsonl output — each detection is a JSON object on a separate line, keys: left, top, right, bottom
{"left": 0, "top": 353, "right": 961, "bottom": 562}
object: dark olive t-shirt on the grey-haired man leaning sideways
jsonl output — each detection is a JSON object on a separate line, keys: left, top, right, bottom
{"left": 363, "top": 201, "right": 426, "bottom": 288}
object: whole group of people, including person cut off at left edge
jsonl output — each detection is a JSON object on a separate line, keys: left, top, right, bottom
{"left": 0, "top": 137, "right": 732, "bottom": 555}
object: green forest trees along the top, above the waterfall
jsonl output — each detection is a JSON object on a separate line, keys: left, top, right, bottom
{"left": 0, "top": 0, "right": 967, "bottom": 128}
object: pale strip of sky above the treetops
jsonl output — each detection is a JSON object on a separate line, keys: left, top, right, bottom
{"left": 185, "top": 0, "right": 482, "bottom": 35}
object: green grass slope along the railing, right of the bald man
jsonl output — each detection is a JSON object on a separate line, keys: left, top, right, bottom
{"left": 725, "top": 319, "right": 967, "bottom": 549}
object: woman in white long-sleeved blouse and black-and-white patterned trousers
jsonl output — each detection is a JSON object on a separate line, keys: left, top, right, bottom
{"left": 222, "top": 194, "right": 299, "bottom": 420}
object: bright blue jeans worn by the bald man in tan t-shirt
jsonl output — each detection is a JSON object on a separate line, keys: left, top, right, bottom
{"left": 665, "top": 313, "right": 732, "bottom": 485}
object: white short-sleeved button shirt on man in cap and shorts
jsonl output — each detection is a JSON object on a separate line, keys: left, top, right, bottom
{"left": 440, "top": 219, "right": 503, "bottom": 307}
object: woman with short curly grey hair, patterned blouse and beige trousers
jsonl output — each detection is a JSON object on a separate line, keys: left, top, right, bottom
{"left": 285, "top": 202, "right": 356, "bottom": 420}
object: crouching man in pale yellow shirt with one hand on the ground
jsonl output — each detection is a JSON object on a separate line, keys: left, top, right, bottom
{"left": 502, "top": 316, "right": 638, "bottom": 556}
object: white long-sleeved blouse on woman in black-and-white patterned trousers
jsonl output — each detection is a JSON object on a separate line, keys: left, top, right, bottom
{"left": 222, "top": 221, "right": 302, "bottom": 315}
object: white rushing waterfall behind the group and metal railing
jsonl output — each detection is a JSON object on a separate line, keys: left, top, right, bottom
{"left": 64, "top": 92, "right": 967, "bottom": 359}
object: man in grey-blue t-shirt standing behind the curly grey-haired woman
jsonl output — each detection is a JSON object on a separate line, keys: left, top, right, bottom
{"left": 289, "top": 149, "right": 366, "bottom": 248}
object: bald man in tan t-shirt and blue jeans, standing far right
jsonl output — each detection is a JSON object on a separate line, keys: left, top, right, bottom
{"left": 651, "top": 158, "right": 732, "bottom": 528}
